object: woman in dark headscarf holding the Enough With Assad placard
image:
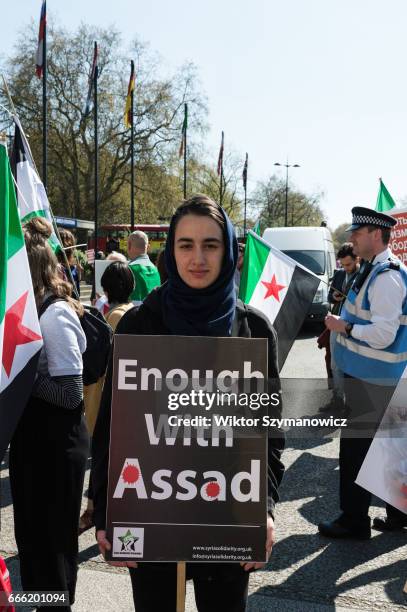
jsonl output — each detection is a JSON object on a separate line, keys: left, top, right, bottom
{"left": 92, "top": 195, "right": 284, "bottom": 612}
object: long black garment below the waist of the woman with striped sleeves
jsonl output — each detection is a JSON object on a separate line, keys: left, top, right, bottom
{"left": 10, "top": 398, "right": 89, "bottom": 611}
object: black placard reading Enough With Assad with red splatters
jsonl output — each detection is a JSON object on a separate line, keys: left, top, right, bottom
{"left": 107, "top": 335, "right": 274, "bottom": 562}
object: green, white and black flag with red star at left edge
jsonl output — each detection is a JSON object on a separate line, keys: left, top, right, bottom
{"left": 0, "top": 143, "right": 42, "bottom": 461}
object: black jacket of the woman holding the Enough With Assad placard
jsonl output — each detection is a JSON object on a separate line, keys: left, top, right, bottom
{"left": 92, "top": 289, "right": 284, "bottom": 529}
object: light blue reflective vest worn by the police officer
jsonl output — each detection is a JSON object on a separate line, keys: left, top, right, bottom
{"left": 334, "top": 261, "right": 407, "bottom": 386}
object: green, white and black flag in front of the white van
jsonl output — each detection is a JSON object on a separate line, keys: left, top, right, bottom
{"left": 239, "top": 231, "right": 320, "bottom": 369}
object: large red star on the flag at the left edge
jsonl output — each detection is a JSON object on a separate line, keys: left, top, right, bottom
{"left": 3, "top": 291, "right": 41, "bottom": 376}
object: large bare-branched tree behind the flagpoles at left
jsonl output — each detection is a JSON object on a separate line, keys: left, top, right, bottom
{"left": 1, "top": 23, "right": 206, "bottom": 222}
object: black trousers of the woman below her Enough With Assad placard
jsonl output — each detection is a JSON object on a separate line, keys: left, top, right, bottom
{"left": 129, "top": 563, "right": 250, "bottom": 612}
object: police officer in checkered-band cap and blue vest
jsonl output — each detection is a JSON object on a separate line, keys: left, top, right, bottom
{"left": 318, "top": 206, "right": 407, "bottom": 539}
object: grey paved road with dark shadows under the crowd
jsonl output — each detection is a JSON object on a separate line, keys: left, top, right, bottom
{"left": 0, "top": 329, "right": 407, "bottom": 612}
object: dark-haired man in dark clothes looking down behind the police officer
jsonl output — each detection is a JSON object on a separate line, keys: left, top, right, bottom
{"left": 318, "top": 242, "right": 359, "bottom": 412}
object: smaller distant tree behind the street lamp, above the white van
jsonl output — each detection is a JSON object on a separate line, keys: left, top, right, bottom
{"left": 251, "top": 175, "right": 324, "bottom": 227}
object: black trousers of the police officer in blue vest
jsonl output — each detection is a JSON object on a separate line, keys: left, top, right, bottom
{"left": 339, "top": 375, "right": 405, "bottom": 525}
